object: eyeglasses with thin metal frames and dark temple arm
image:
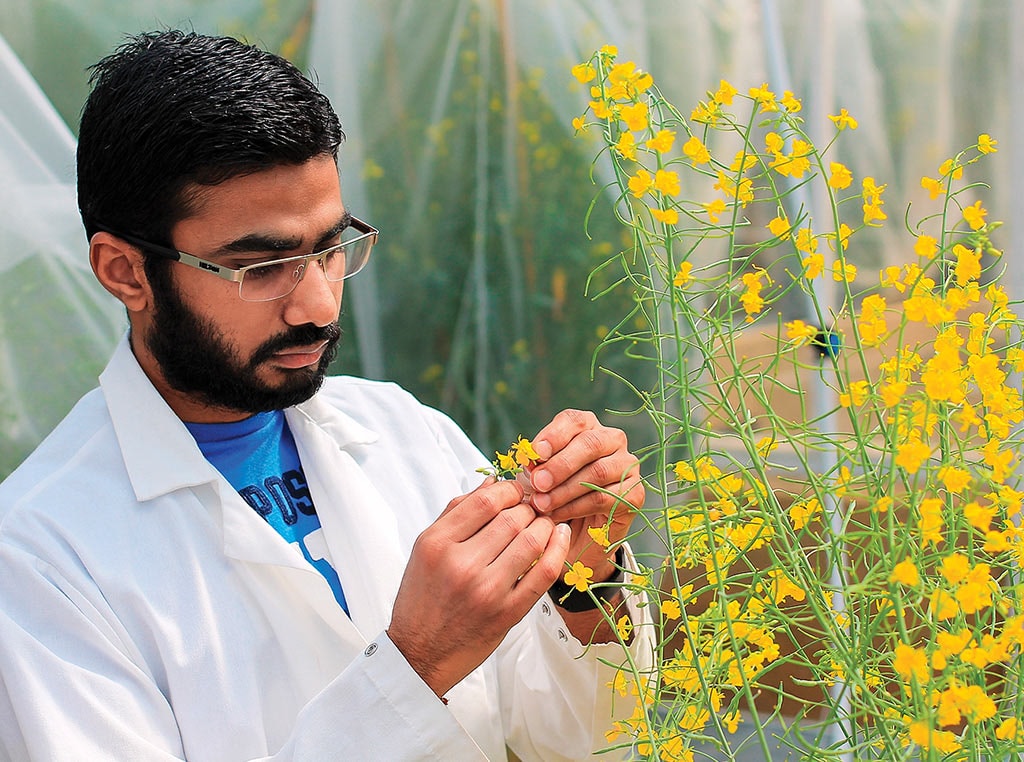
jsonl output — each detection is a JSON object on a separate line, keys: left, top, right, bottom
{"left": 97, "top": 217, "right": 379, "bottom": 301}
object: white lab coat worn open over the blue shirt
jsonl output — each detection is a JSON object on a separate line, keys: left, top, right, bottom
{"left": 0, "top": 341, "right": 651, "bottom": 762}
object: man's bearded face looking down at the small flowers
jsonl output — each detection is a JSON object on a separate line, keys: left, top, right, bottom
{"left": 133, "top": 157, "right": 345, "bottom": 422}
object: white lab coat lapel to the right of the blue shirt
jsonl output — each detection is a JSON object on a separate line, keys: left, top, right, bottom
{"left": 288, "top": 398, "right": 406, "bottom": 637}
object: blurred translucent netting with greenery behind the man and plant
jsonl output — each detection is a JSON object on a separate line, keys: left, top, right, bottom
{"left": 0, "top": 0, "right": 1024, "bottom": 476}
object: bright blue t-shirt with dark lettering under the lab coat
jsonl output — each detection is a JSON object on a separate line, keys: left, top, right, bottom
{"left": 185, "top": 411, "right": 348, "bottom": 613}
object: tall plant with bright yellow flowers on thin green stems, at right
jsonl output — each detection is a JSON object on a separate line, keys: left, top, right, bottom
{"left": 572, "top": 46, "right": 1024, "bottom": 760}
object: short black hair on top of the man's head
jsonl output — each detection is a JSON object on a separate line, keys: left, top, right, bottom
{"left": 78, "top": 30, "right": 344, "bottom": 248}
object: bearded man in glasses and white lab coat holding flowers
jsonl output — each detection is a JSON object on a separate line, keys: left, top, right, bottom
{"left": 0, "top": 32, "right": 650, "bottom": 761}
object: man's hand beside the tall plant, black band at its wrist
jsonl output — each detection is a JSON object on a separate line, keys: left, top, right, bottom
{"left": 530, "top": 410, "right": 644, "bottom": 582}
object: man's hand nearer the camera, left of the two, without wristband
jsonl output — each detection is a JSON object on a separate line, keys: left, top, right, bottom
{"left": 387, "top": 479, "right": 569, "bottom": 696}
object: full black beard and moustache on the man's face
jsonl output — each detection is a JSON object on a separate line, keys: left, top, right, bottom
{"left": 145, "top": 283, "right": 341, "bottom": 414}
